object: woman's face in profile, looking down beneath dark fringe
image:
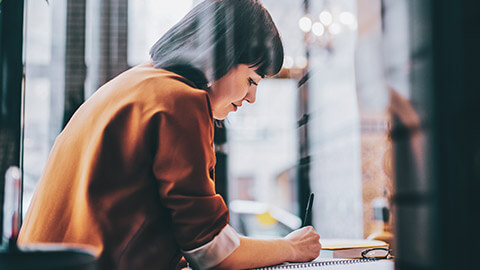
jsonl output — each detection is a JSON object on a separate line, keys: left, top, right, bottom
{"left": 208, "top": 64, "right": 262, "bottom": 120}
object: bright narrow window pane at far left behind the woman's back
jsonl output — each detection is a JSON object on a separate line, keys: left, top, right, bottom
{"left": 23, "top": 0, "right": 65, "bottom": 213}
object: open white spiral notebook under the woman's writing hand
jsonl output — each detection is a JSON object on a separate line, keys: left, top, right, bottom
{"left": 256, "top": 258, "right": 393, "bottom": 270}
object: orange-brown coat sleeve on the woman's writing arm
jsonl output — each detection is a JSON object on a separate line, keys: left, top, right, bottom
{"left": 153, "top": 91, "right": 228, "bottom": 250}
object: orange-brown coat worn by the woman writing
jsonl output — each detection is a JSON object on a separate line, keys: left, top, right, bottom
{"left": 19, "top": 64, "right": 228, "bottom": 269}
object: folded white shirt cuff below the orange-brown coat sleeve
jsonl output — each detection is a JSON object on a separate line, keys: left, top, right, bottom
{"left": 182, "top": 224, "right": 240, "bottom": 269}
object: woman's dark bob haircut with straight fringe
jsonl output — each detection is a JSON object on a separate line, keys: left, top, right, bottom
{"left": 150, "top": 0, "right": 283, "bottom": 89}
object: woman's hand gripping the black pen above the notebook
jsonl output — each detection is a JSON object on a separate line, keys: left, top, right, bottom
{"left": 284, "top": 226, "right": 322, "bottom": 262}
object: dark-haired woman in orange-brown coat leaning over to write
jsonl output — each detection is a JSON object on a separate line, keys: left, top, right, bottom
{"left": 19, "top": 0, "right": 320, "bottom": 269}
